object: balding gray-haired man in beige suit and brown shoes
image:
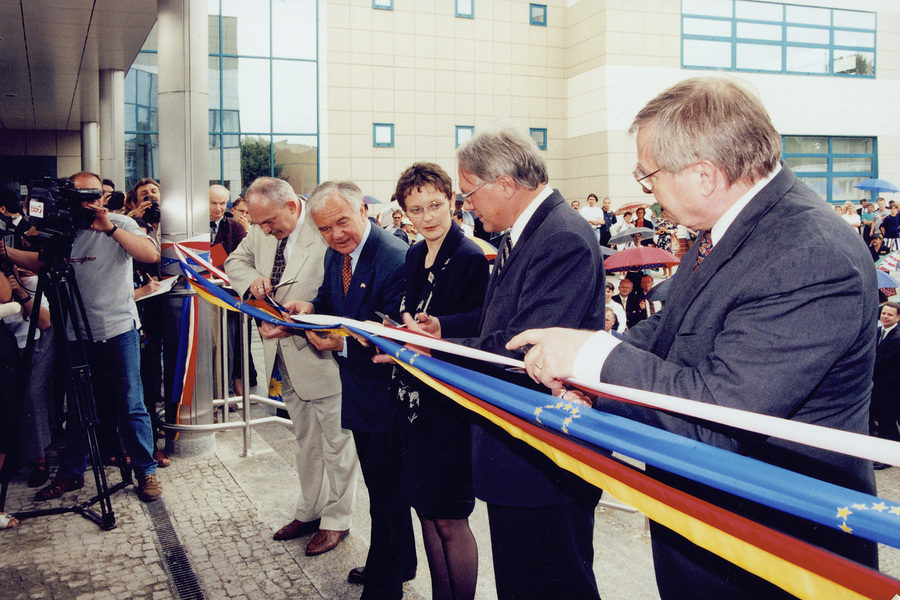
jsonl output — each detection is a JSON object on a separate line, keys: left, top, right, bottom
{"left": 225, "top": 177, "right": 359, "bottom": 556}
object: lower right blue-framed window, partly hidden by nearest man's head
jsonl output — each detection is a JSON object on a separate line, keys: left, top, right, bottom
{"left": 782, "top": 135, "right": 878, "bottom": 204}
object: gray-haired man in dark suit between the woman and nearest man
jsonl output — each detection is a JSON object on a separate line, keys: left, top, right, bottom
{"left": 410, "top": 127, "right": 605, "bottom": 600}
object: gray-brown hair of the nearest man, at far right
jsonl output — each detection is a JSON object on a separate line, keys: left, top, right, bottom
{"left": 628, "top": 77, "right": 781, "bottom": 183}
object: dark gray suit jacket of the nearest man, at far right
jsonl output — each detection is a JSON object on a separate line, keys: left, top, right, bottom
{"left": 598, "top": 166, "right": 877, "bottom": 593}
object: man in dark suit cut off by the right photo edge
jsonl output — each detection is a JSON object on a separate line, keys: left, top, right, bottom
{"left": 870, "top": 302, "right": 900, "bottom": 448}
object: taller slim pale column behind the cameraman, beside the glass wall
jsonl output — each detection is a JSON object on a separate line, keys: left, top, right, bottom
{"left": 98, "top": 69, "right": 127, "bottom": 191}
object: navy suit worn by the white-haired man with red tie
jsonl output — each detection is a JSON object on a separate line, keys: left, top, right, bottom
{"left": 313, "top": 225, "right": 416, "bottom": 600}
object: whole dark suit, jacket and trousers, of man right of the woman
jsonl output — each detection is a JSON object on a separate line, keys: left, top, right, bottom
{"left": 463, "top": 191, "right": 605, "bottom": 600}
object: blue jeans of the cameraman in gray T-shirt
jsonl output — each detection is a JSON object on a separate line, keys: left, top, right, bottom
{"left": 57, "top": 329, "right": 156, "bottom": 479}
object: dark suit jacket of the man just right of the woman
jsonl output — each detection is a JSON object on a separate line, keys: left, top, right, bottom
{"left": 463, "top": 191, "right": 606, "bottom": 507}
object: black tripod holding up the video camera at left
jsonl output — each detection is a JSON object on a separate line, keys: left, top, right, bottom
{"left": 0, "top": 260, "right": 133, "bottom": 531}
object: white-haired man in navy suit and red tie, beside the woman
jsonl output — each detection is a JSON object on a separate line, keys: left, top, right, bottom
{"left": 287, "top": 181, "right": 416, "bottom": 600}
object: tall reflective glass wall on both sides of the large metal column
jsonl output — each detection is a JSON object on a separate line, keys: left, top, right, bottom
{"left": 125, "top": 0, "right": 319, "bottom": 196}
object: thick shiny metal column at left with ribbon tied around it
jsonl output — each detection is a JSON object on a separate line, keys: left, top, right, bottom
{"left": 157, "top": 0, "right": 216, "bottom": 455}
